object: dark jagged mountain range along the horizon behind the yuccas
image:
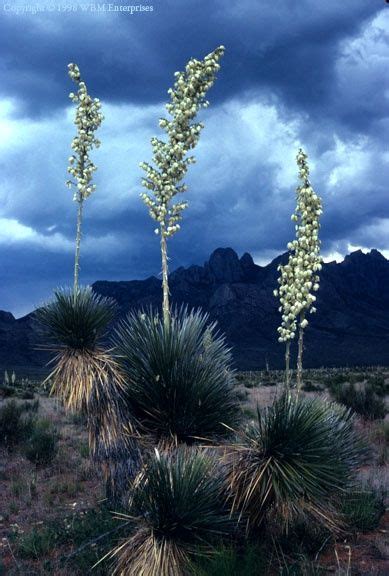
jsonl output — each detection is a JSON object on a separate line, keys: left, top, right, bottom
{"left": 0, "top": 248, "right": 389, "bottom": 370}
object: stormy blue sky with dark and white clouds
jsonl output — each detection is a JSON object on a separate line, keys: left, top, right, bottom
{"left": 0, "top": 0, "right": 389, "bottom": 316}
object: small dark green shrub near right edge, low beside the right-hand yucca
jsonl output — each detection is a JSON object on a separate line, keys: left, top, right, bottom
{"left": 341, "top": 487, "right": 385, "bottom": 532}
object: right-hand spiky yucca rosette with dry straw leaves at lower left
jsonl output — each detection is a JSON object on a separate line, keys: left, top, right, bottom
{"left": 230, "top": 393, "right": 364, "bottom": 529}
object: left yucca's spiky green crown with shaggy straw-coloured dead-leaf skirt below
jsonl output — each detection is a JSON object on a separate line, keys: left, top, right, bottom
{"left": 35, "top": 287, "right": 135, "bottom": 466}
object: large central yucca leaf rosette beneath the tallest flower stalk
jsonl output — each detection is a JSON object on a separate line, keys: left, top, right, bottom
{"left": 114, "top": 308, "right": 239, "bottom": 443}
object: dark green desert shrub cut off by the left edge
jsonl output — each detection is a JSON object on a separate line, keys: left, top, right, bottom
{"left": 0, "top": 400, "right": 33, "bottom": 447}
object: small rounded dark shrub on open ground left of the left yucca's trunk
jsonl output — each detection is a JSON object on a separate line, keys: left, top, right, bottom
{"left": 24, "top": 419, "right": 59, "bottom": 466}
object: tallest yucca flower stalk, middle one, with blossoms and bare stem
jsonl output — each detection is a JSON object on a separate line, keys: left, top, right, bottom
{"left": 140, "top": 46, "right": 224, "bottom": 327}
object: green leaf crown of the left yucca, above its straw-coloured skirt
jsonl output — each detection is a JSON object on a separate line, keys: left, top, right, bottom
{"left": 35, "top": 287, "right": 117, "bottom": 351}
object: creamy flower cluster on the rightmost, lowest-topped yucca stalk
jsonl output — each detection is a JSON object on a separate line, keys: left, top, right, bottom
{"left": 274, "top": 149, "right": 322, "bottom": 342}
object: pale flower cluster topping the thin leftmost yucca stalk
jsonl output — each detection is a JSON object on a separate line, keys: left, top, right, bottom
{"left": 66, "top": 64, "right": 104, "bottom": 202}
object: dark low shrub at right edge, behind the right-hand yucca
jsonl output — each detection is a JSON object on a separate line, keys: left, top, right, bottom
{"left": 332, "top": 384, "right": 387, "bottom": 420}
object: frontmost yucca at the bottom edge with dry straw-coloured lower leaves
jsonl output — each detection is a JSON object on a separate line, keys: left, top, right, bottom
{"left": 110, "top": 447, "right": 234, "bottom": 576}
